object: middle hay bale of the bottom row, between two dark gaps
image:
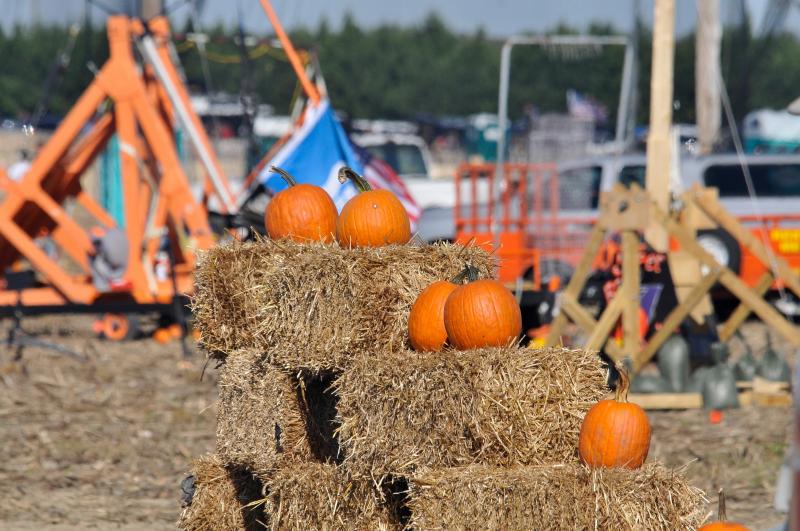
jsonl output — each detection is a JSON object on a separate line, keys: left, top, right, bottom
{"left": 262, "top": 463, "right": 399, "bottom": 531}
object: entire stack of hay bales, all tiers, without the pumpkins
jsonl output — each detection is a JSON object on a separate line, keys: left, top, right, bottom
{"left": 179, "top": 240, "right": 702, "bottom": 531}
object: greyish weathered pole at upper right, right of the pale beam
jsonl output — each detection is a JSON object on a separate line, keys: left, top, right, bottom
{"left": 694, "top": 0, "right": 722, "bottom": 155}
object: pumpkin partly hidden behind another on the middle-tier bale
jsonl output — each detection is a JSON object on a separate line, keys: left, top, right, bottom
{"left": 408, "top": 280, "right": 457, "bottom": 352}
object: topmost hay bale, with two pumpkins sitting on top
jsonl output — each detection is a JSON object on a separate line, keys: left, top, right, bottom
{"left": 192, "top": 240, "right": 494, "bottom": 371}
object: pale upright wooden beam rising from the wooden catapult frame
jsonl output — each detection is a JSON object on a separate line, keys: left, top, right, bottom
{"left": 645, "top": 0, "right": 675, "bottom": 252}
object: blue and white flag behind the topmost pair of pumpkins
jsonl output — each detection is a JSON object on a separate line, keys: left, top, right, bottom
{"left": 258, "top": 100, "right": 364, "bottom": 210}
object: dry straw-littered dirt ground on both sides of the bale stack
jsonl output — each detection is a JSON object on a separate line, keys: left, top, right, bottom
{"left": 0, "top": 317, "right": 791, "bottom": 531}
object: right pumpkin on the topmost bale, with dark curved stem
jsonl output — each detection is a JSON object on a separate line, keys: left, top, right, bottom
{"left": 336, "top": 166, "right": 411, "bottom": 247}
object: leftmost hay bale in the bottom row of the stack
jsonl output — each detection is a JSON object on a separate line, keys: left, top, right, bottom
{"left": 178, "top": 455, "right": 266, "bottom": 531}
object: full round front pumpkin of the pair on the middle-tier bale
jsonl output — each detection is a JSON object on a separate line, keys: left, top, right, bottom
{"left": 444, "top": 266, "right": 522, "bottom": 350}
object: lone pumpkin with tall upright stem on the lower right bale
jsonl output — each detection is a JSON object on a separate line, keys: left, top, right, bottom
{"left": 578, "top": 363, "right": 650, "bottom": 468}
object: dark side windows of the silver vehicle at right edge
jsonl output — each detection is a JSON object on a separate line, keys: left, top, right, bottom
{"left": 703, "top": 164, "right": 800, "bottom": 197}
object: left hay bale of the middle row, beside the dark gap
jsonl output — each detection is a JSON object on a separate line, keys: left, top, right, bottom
{"left": 217, "top": 351, "right": 336, "bottom": 472}
